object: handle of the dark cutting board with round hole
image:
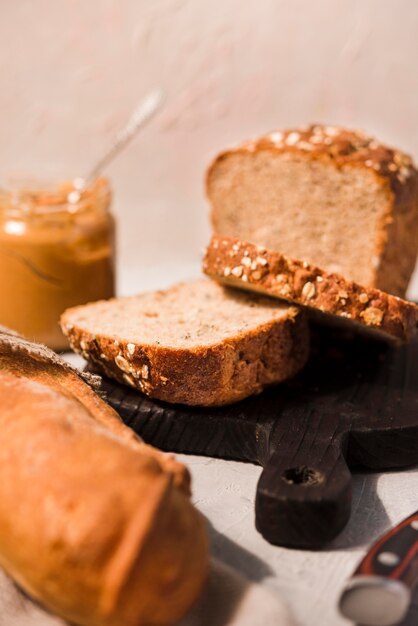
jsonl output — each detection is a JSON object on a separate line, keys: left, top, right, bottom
{"left": 256, "top": 443, "right": 351, "bottom": 549}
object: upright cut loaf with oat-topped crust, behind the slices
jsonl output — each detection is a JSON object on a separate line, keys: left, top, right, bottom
{"left": 207, "top": 124, "right": 418, "bottom": 297}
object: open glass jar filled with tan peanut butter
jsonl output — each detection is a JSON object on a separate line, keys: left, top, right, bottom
{"left": 0, "top": 178, "right": 115, "bottom": 350}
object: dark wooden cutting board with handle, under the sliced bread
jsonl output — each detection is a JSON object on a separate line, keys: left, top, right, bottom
{"left": 96, "top": 330, "right": 418, "bottom": 549}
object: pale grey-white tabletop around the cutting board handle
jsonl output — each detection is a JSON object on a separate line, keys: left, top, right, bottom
{"left": 66, "top": 266, "right": 418, "bottom": 626}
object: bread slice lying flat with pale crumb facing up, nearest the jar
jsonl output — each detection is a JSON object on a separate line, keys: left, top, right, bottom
{"left": 61, "top": 279, "right": 309, "bottom": 406}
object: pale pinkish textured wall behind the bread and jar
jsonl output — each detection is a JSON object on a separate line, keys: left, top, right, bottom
{"left": 0, "top": 0, "right": 418, "bottom": 295}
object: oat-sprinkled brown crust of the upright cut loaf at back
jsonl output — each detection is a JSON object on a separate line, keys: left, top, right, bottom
{"left": 206, "top": 124, "right": 418, "bottom": 297}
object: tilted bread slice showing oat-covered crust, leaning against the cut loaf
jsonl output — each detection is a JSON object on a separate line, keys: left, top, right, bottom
{"left": 203, "top": 235, "right": 418, "bottom": 341}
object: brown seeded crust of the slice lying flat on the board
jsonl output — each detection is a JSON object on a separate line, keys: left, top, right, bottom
{"left": 61, "top": 286, "right": 309, "bottom": 406}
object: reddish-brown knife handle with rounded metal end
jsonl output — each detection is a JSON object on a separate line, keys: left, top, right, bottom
{"left": 340, "top": 511, "right": 418, "bottom": 626}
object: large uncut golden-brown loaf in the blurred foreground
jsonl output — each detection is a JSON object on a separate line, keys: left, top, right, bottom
{"left": 0, "top": 324, "right": 208, "bottom": 626}
